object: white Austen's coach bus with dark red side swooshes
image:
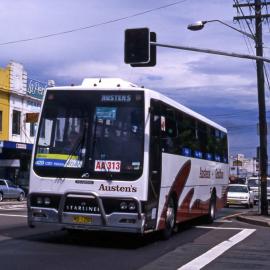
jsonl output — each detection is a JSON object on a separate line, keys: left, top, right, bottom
{"left": 28, "top": 78, "right": 228, "bottom": 238}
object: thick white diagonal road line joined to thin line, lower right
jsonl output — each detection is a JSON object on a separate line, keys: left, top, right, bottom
{"left": 177, "top": 226, "right": 256, "bottom": 270}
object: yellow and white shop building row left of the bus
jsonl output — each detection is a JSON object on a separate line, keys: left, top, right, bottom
{"left": 0, "top": 62, "right": 46, "bottom": 192}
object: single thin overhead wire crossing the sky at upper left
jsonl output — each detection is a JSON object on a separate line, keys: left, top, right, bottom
{"left": 0, "top": 0, "right": 188, "bottom": 46}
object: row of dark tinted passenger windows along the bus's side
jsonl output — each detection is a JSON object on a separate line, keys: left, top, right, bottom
{"left": 156, "top": 102, "right": 228, "bottom": 163}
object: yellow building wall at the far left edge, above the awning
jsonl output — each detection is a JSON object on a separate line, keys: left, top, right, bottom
{"left": 0, "top": 67, "right": 10, "bottom": 141}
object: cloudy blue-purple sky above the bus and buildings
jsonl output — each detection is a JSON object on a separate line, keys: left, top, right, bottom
{"left": 0, "top": 0, "right": 270, "bottom": 157}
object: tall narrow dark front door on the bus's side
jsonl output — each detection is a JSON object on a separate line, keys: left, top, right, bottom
{"left": 145, "top": 99, "right": 162, "bottom": 229}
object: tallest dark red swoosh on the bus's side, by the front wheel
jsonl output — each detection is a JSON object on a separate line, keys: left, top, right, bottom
{"left": 158, "top": 160, "right": 191, "bottom": 229}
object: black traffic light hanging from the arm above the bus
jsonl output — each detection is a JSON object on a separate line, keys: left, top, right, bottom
{"left": 125, "top": 28, "right": 156, "bottom": 67}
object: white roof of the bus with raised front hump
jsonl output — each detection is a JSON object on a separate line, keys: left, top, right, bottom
{"left": 48, "top": 78, "right": 227, "bottom": 133}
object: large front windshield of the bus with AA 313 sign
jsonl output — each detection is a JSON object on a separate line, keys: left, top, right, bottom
{"left": 34, "top": 90, "right": 144, "bottom": 180}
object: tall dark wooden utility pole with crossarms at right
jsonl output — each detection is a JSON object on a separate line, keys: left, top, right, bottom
{"left": 234, "top": 0, "right": 270, "bottom": 215}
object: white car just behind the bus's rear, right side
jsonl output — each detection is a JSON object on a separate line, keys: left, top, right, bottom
{"left": 226, "top": 184, "right": 254, "bottom": 208}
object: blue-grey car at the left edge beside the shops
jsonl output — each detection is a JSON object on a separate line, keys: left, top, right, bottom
{"left": 0, "top": 179, "right": 25, "bottom": 202}
